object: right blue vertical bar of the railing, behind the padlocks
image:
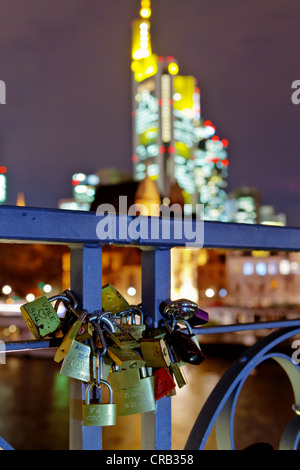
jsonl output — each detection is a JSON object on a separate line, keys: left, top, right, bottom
{"left": 142, "top": 250, "right": 172, "bottom": 450}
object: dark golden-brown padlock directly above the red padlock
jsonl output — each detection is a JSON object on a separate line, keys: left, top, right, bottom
{"left": 140, "top": 338, "right": 171, "bottom": 368}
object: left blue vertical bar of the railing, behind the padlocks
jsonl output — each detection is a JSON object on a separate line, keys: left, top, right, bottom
{"left": 69, "top": 245, "right": 102, "bottom": 450}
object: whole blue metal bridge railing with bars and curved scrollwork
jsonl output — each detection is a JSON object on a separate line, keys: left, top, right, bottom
{"left": 0, "top": 206, "right": 300, "bottom": 450}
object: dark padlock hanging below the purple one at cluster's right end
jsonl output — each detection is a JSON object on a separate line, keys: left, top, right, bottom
{"left": 165, "top": 320, "right": 206, "bottom": 365}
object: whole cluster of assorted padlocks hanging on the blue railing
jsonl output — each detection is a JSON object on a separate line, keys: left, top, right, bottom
{"left": 21, "top": 285, "right": 208, "bottom": 426}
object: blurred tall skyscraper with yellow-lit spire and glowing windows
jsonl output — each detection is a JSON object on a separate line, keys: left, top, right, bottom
{"left": 132, "top": 0, "right": 228, "bottom": 216}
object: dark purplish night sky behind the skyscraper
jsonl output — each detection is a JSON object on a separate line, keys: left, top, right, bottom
{"left": 0, "top": 0, "right": 300, "bottom": 226}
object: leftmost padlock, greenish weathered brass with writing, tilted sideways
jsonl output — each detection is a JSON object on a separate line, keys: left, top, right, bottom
{"left": 21, "top": 297, "right": 61, "bottom": 340}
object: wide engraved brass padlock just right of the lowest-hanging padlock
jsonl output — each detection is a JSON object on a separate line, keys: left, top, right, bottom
{"left": 114, "top": 367, "right": 156, "bottom": 416}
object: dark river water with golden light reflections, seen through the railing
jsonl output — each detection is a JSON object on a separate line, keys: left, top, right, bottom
{"left": 0, "top": 348, "right": 294, "bottom": 450}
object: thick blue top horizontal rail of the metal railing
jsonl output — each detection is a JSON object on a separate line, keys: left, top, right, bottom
{"left": 0, "top": 206, "right": 300, "bottom": 251}
